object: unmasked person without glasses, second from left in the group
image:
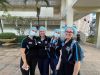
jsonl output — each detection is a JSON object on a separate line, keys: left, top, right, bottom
{"left": 38, "top": 26, "right": 51, "bottom": 75}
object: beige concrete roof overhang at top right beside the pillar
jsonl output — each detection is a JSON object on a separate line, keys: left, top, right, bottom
{"left": 73, "top": 0, "right": 100, "bottom": 20}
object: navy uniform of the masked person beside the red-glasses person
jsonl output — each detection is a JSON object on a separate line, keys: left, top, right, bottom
{"left": 50, "top": 38, "right": 62, "bottom": 75}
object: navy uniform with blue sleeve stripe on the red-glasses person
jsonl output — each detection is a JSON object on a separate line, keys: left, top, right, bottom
{"left": 57, "top": 39, "right": 81, "bottom": 75}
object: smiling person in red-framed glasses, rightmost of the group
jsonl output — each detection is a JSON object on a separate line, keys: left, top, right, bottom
{"left": 56, "top": 27, "right": 82, "bottom": 75}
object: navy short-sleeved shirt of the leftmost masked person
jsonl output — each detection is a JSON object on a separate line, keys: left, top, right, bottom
{"left": 21, "top": 37, "right": 38, "bottom": 57}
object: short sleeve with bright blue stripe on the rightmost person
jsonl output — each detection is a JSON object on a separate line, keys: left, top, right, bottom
{"left": 73, "top": 42, "right": 82, "bottom": 61}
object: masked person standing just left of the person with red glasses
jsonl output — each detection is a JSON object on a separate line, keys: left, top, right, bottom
{"left": 49, "top": 29, "right": 62, "bottom": 75}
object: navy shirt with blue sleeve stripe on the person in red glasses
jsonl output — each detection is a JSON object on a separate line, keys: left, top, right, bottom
{"left": 62, "top": 39, "right": 81, "bottom": 62}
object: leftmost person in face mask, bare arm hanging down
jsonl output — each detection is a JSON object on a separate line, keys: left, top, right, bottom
{"left": 20, "top": 27, "right": 38, "bottom": 75}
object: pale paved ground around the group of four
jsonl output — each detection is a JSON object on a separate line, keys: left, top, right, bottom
{"left": 0, "top": 45, "right": 100, "bottom": 75}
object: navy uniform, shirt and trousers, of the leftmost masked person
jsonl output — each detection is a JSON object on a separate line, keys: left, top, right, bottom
{"left": 20, "top": 37, "right": 38, "bottom": 75}
